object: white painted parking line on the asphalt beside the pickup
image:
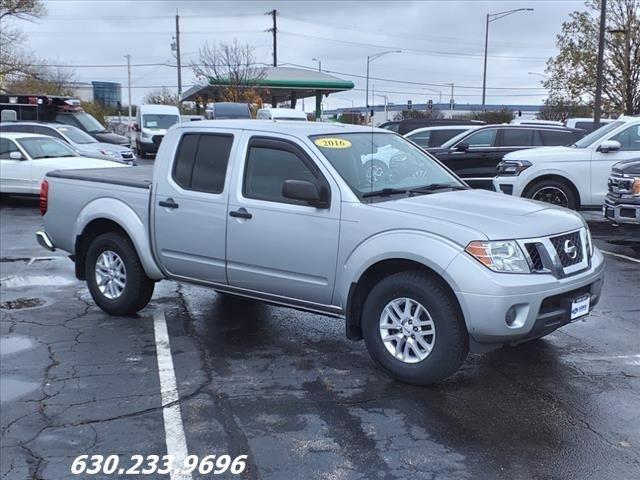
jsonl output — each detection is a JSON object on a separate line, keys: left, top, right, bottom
{"left": 153, "top": 312, "right": 193, "bottom": 480}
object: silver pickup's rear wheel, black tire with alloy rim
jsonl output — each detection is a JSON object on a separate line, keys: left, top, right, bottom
{"left": 85, "top": 233, "right": 155, "bottom": 316}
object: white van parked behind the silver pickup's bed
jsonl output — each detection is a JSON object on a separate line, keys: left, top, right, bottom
{"left": 133, "top": 105, "right": 180, "bottom": 158}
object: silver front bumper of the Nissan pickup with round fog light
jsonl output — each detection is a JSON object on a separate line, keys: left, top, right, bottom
{"left": 447, "top": 249, "right": 604, "bottom": 347}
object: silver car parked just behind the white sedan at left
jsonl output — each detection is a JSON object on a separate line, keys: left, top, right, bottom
{"left": 0, "top": 122, "right": 136, "bottom": 165}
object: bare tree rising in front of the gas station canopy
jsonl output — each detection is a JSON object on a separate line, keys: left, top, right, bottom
{"left": 191, "top": 40, "right": 265, "bottom": 103}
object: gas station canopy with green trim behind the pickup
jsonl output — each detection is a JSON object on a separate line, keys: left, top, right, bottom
{"left": 181, "top": 67, "right": 354, "bottom": 117}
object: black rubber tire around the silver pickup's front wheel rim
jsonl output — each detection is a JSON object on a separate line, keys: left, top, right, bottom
{"left": 362, "top": 271, "right": 469, "bottom": 385}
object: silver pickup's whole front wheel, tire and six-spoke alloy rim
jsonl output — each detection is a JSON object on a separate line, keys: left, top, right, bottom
{"left": 362, "top": 271, "right": 469, "bottom": 385}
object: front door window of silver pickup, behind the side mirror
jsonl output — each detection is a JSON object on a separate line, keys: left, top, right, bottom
{"left": 243, "top": 142, "right": 318, "bottom": 204}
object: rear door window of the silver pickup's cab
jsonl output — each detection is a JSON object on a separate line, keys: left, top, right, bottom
{"left": 173, "top": 133, "right": 233, "bottom": 193}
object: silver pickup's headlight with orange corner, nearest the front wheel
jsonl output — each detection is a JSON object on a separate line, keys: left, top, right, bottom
{"left": 465, "top": 240, "right": 531, "bottom": 273}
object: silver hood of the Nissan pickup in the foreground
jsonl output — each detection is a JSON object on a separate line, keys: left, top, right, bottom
{"left": 372, "top": 190, "right": 584, "bottom": 243}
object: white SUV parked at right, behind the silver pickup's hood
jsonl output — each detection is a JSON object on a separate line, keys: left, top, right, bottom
{"left": 493, "top": 117, "right": 640, "bottom": 209}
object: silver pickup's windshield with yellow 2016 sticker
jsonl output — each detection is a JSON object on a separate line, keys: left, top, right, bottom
{"left": 310, "top": 132, "right": 467, "bottom": 199}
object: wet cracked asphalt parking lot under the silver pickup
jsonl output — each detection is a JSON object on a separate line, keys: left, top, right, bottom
{"left": 0, "top": 193, "right": 640, "bottom": 480}
